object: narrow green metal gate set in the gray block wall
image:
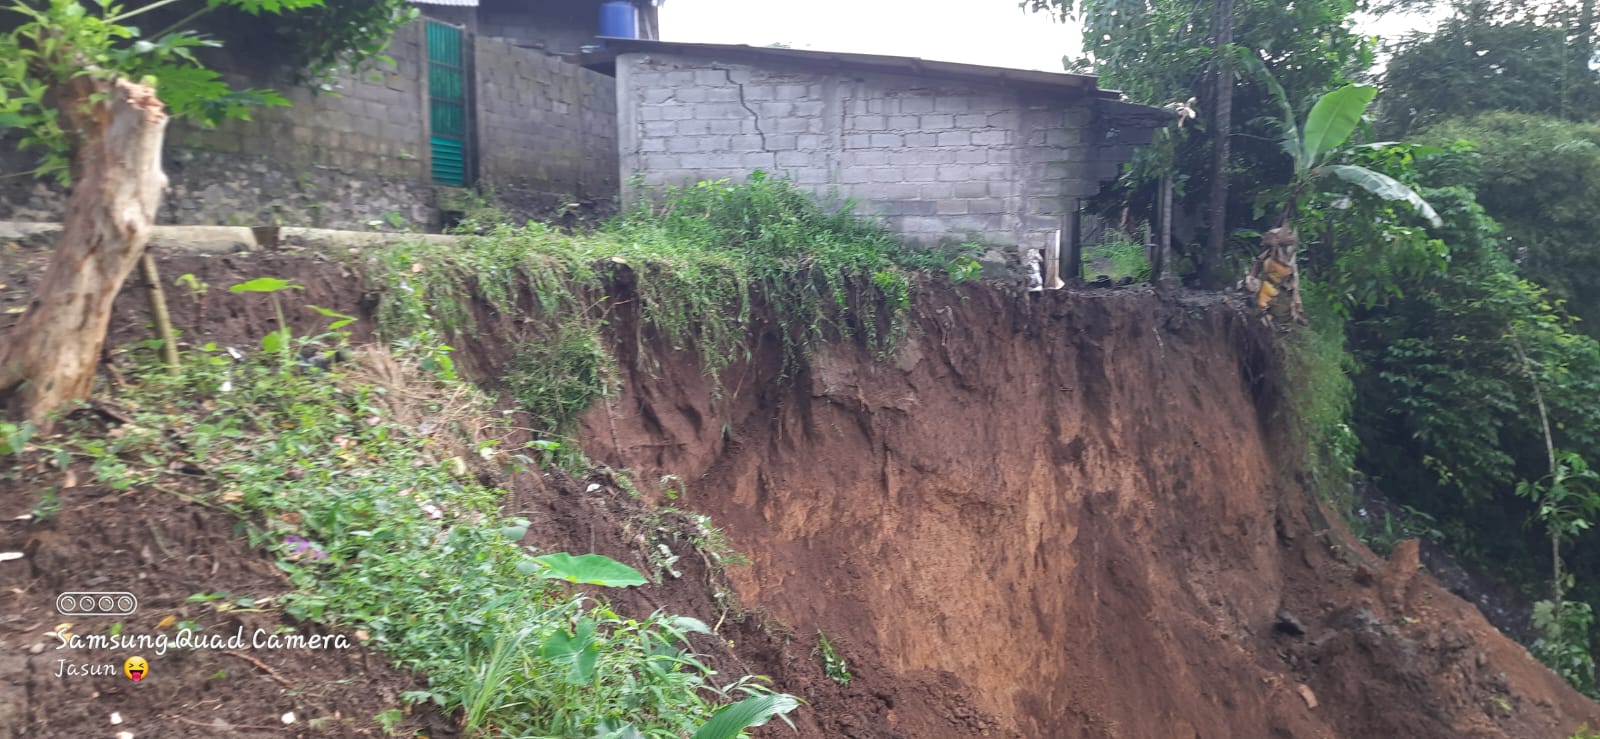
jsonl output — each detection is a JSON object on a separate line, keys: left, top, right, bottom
{"left": 427, "top": 19, "right": 472, "bottom": 187}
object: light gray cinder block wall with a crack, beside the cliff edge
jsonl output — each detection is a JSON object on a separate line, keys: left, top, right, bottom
{"left": 618, "top": 53, "right": 1147, "bottom": 254}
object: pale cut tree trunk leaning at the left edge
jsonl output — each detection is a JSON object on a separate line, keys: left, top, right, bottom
{"left": 0, "top": 75, "right": 166, "bottom": 429}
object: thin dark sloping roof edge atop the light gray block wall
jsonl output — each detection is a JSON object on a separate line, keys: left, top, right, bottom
{"left": 579, "top": 38, "right": 1122, "bottom": 101}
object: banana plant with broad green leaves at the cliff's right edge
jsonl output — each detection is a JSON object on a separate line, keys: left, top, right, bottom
{"left": 1237, "top": 48, "right": 1440, "bottom": 229}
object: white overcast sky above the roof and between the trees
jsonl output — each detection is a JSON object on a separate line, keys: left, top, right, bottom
{"left": 661, "top": 0, "right": 1452, "bottom": 72}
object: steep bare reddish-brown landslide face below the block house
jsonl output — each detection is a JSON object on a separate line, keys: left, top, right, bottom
{"left": 589, "top": 286, "right": 1600, "bottom": 737}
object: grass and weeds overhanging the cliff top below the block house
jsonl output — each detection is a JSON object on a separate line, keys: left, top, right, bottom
{"left": 374, "top": 171, "right": 978, "bottom": 380}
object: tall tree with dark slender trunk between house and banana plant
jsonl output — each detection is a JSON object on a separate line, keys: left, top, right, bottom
{"left": 1024, "top": 0, "right": 1373, "bottom": 281}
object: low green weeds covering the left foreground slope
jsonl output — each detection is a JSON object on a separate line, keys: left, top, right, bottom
{"left": 21, "top": 315, "right": 795, "bottom": 739}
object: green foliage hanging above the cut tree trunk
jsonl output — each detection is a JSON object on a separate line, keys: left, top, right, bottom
{"left": 0, "top": 0, "right": 418, "bottom": 179}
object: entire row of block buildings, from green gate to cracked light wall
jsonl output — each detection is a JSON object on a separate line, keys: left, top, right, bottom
{"left": 0, "top": 0, "right": 1170, "bottom": 261}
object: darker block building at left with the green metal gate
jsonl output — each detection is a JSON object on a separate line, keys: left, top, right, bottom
{"left": 0, "top": 0, "right": 658, "bottom": 230}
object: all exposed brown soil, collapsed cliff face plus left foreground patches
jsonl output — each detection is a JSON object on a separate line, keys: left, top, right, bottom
{"left": 0, "top": 243, "right": 1600, "bottom": 739}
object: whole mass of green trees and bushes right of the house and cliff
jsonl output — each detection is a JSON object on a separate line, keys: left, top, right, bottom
{"left": 1030, "top": 0, "right": 1600, "bottom": 693}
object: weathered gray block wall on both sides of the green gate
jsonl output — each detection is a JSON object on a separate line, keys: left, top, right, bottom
{"left": 0, "top": 22, "right": 618, "bottom": 230}
